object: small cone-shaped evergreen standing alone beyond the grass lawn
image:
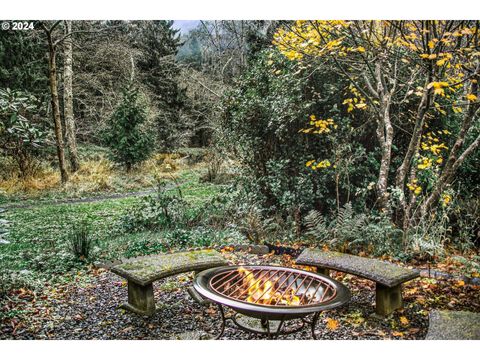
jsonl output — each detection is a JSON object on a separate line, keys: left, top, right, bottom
{"left": 104, "top": 86, "right": 154, "bottom": 171}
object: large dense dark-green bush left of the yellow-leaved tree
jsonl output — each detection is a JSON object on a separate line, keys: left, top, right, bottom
{"left": 221, "top": 49, "right": 378, "bottom": 226}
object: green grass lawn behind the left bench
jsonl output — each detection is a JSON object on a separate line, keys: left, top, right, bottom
{"left": 0, "top": 171, "right": 232, "bottom": 292}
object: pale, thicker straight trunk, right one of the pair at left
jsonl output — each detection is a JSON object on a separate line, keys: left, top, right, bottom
{"left": 63, "top": 20, "right": 80, "bottom": 172}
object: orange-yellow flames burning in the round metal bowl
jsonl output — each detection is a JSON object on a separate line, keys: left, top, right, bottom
{"left": 238, "top": 267, "right": 300, "bottom": 305}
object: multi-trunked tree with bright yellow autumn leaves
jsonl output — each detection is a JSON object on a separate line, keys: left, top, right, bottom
{"left": 275, "top": 20, "right": 480, "bottom": 242}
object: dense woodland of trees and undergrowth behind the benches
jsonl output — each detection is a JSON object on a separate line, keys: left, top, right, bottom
{"left": 0, "top": 20, "right": 480, "bottom": 292}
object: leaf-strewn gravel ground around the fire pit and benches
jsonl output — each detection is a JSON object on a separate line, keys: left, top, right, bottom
{"left": 0, "top": 252, "right": 478, "bottom": 339}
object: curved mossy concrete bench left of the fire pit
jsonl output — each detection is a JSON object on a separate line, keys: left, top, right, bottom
{"left": 111, "top": 250, "right": 227, "bottom": 315}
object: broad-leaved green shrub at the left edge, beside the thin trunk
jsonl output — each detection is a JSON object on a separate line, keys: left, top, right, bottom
{"left": 0, "top": 88, "right": 50, "bottom": 177}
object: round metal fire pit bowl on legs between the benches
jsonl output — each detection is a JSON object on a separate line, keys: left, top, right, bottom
{"left": 193, "top": 266, "right": 350, "bottom": 338}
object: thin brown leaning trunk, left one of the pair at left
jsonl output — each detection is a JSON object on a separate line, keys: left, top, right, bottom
{"left": 46, "top": 30, "right": 68, "bottom": 184}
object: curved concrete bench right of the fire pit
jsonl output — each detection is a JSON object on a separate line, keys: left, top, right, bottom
{"left": 295, "top": 249, "right": 420, "bottom": 316}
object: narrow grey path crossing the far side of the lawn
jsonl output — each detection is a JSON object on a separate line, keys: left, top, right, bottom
{"left": 0, "top": 182, "right": 184, "bottom": 210}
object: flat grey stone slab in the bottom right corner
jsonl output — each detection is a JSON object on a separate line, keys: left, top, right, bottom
{"left": 425, "top": 310, "right": 480, "bottom": 340}
